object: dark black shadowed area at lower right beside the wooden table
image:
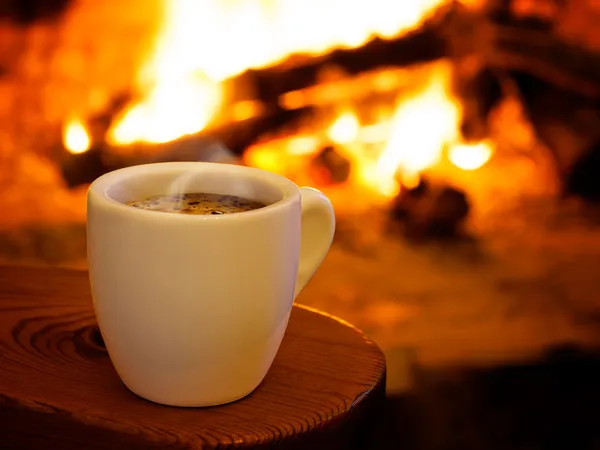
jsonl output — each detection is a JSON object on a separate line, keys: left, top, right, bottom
{"left": 368, "top": 349, "right": 600, "bottom": 450}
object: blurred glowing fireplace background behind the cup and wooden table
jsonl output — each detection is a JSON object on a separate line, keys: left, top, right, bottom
{"left": 0, "top": 0, "right": 600, "bottom": 449}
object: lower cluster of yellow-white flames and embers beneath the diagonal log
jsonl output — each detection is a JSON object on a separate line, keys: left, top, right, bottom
{"left": 244, "top": 62, "right": 493, "bottom": 198}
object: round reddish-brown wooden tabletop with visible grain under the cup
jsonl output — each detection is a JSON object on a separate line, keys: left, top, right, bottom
{"left": 0, "top": 266, "right": 385, "bottom": 450}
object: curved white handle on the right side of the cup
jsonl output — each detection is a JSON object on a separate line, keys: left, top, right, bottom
{"left": 294, "top": 187, "right": 335, "bottom": 298}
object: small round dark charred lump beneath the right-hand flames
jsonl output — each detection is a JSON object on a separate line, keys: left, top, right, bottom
{"left": 390, "top": 179, "right": 470, "bottom": 238}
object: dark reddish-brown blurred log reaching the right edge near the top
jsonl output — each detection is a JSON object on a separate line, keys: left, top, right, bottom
{"left": 440, "top": 0, "right": 600, "bottom": 98}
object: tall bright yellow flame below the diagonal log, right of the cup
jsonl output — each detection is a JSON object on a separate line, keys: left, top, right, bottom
{"left": 329, "top": 63, "right": 460, "bottom": 197}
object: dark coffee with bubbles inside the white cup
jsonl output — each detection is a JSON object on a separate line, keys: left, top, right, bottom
{"left": 127, "top": 192, "right": 266, "bottom": 215}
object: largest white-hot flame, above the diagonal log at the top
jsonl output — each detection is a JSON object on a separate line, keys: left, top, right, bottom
{"left": 108, "top": 0, "right": 447, "bottom": 145}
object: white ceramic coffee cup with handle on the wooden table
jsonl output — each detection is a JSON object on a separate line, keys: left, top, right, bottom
{"left": 87, "top": 162, "right": 335, "bottom": 406}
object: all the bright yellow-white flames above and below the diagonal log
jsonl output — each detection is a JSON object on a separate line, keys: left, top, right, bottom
{"left": 64, "top": 0, "right": 493, "bottom": 198}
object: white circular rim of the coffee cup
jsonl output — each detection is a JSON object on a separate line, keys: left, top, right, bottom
{"left": 87, "top": 161, "right": 300, "bottom": 221}
